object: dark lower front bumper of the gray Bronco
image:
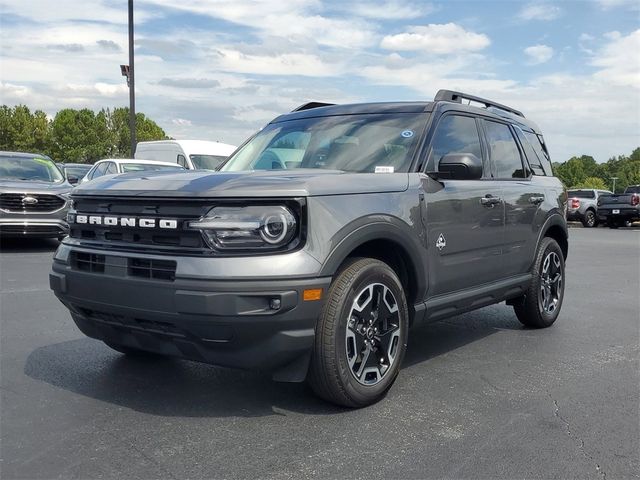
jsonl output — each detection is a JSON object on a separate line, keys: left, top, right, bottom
{"left": 49, "top": 246, "right": 331, "bottom": 381}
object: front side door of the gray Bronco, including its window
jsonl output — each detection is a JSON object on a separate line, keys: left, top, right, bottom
{"left": 423, "top": 113, "right": 504, "bottom": 297}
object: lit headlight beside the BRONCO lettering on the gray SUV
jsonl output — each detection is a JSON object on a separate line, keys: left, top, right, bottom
{"left": 189, "top": 205, "right": 298, "bottom": 250}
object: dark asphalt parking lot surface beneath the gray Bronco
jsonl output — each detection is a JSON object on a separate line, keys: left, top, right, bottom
{"left": 0, "top": 229, "right": 640, "bottom": 479}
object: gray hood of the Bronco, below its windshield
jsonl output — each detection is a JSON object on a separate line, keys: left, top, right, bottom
{"left": 73, "top": 169, "right": 409, "bottom": 198}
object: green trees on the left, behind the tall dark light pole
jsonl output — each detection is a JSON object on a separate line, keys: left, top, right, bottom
{"left": 0, "top": 105, "right": 168, "bottom": 163}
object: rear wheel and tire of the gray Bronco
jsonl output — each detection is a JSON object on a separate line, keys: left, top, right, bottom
{"left": 513, "top": 237, "right": 565, "bottom": 328}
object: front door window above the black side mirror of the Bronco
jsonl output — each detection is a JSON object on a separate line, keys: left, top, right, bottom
{"left": 427, "top": 115, "right": 482, "bottom": 171}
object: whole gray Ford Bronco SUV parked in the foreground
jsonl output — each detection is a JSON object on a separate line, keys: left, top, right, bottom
{"left": 50, "top": 91, "right": 568, "bottom": 407}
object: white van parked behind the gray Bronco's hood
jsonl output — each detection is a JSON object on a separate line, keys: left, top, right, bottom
{"left": 135, "top": 140, "right": 236, "bottom": 170}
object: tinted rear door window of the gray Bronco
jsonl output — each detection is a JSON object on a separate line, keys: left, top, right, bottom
{"left": 485, "top": 121, "right": 526, "bottom": 178}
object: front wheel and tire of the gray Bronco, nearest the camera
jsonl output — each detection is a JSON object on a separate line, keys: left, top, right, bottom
{"left": 307, "top": 258, "right": 409, "bottom": 407}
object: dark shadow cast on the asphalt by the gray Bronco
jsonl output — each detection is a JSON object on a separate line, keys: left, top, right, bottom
{"left": 24, "top": 307, "right": 522, "bottom": 417}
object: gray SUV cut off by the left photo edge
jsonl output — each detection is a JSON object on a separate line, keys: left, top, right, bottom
{"left": 0, "top": 152, "right": 73, "bottom": 238}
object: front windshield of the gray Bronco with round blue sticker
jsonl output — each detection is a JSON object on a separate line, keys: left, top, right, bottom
{"left": 220, "top": 113, "right": 427, "bottom": 173}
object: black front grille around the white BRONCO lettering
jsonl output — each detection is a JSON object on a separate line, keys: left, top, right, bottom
{"left": 70, "top": 197, "right": 213, "bottom": 253}
